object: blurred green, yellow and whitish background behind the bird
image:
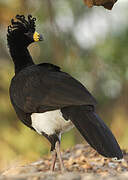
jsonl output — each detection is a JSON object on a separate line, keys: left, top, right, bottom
{"left": 0, "top": 0, "right": 128, "bottom": 172}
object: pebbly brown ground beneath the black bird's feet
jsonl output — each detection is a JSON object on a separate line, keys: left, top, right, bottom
{"left": 0, "top": 144, "right": 128, "bottom": 180}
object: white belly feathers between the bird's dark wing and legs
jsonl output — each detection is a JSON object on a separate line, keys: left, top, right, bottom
{"left": 31, "top": 110, "right": 73, "bottom": 135}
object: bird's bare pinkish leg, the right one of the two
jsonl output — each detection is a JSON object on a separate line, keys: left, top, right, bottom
{"left": 55, "top": 141, "right": 65, "bottom": 172}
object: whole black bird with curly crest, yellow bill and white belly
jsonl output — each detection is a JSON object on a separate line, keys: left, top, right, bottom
{"left": 7, "top": 15, "right": 123, "bottom": 171}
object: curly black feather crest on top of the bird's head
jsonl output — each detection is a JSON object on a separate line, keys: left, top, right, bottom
{"left": 8, "top": 15, "right": 36, "bottom": 34}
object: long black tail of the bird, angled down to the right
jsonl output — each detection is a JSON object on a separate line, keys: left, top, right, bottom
{"left": 62, "top": 106, "right": 123, "bottom": 159}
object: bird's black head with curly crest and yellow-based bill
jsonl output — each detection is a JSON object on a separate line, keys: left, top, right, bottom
{"left": 7, "top": 15, "right": 43, "bottom": 47}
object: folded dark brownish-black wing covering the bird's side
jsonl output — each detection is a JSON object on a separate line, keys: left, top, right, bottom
{"left": 10, "top": 64, "right": 96, "bottom": 113}
